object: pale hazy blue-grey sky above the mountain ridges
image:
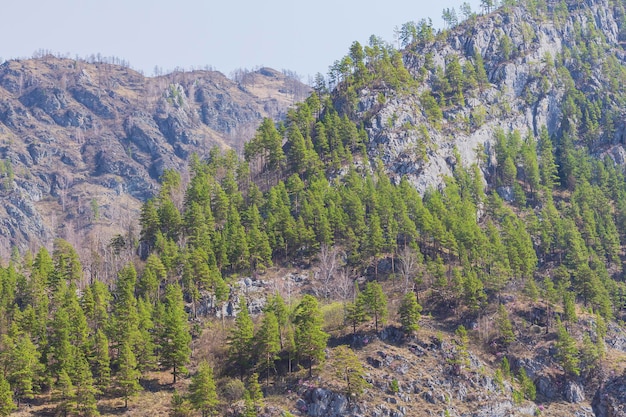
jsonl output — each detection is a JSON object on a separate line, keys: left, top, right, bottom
{"left": 0, "top": 0, "right": 479, "bottom": 81}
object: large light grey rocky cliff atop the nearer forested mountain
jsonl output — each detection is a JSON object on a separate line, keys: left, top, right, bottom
{"left": 354, "top": 0, "right": 626, "bottom": 192}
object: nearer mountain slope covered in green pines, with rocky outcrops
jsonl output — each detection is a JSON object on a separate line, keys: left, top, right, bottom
{"left": 0, "top": 0, "right": 626, "bottom": 417}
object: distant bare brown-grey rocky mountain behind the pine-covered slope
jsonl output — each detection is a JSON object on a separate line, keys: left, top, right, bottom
{"left": 0, "top": 56, "right": 309, "bottom": 258}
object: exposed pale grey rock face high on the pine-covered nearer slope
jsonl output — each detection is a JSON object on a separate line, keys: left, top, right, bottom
{"left": 348, "top": 0, "right": 626, "bottom": 193}
